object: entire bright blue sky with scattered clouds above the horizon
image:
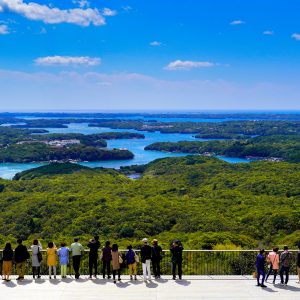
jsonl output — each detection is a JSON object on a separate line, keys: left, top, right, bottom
{"left": 0, "top": 0, "right": 300, "bottom": 111}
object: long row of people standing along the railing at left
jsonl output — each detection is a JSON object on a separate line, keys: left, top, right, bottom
{"left": 2, "top": 236, "right": 183, "bottom": 283}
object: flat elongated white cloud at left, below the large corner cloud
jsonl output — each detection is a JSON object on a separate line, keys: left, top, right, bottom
{"left": 34, "top": 55, "right": 101, "bottom": 66}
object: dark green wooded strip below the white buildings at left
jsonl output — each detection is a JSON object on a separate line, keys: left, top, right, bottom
{"left": 0, "top": 142, "right": 134, "bottom": 163}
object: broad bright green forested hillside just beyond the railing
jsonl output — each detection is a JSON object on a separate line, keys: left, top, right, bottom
{"left": 0, "top": 156, "right": 300, "bottom": 249}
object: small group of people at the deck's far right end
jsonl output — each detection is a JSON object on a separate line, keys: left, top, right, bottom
{"left": 256, "top": 244, "right": 300, "bottom": 288}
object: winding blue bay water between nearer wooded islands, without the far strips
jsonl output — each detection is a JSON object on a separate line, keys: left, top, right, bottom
{"left": 0, "top": 119, "right": 249, "bottom": 179}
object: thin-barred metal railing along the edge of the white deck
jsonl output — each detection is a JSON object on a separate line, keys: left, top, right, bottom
{"left": 0, "top": 250, "right": 297, "bottom": 275}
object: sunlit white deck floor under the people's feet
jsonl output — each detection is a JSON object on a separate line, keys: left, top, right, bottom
{"left": 0, "top": 276, "right": 300, "bottom": 300}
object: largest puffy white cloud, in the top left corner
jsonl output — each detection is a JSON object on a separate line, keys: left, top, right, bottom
{"left": 0, "top": 0, "right": 105, "bottom": 26}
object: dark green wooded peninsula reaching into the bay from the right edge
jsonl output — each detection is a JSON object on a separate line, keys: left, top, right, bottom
{"left": 145, "top": 135, "right": 300, "bottom": 162}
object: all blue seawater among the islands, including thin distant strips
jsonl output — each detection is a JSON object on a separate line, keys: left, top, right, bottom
{"left": 0, "top": 115, "right": 296, "bottom": 179}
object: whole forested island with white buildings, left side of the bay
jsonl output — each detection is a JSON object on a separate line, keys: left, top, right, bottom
{"left": 0, "top": 127, "right": 139, "bottom": 163}
